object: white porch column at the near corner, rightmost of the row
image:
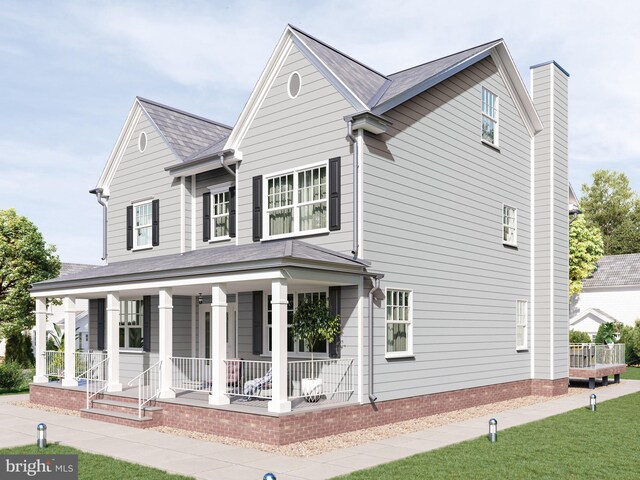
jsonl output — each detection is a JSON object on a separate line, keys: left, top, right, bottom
{"left": 267, "top": 279, "right": 291, "bottom": 413}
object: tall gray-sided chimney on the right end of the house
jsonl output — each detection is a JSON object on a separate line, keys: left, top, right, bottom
{"left": 532, "top": 64, "right": 569, "bottom": 378}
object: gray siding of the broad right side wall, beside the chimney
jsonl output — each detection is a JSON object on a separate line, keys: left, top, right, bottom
{"left": 364, "top": 59, "right": 531, "bottom": 400}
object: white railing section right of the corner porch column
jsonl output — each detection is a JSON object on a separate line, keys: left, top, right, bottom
{"left": 287, "top": 358, "right": 353, "bottom": 402}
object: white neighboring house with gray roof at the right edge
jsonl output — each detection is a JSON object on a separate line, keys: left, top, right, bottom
{"left": 570, "top": 253, "right": 640, "bottom": 333}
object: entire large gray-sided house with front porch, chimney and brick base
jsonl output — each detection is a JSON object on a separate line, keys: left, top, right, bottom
{"left": 32, "top": 26, "right": 569, "bottom": 443}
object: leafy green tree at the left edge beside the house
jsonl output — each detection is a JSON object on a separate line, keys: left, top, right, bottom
{"left": 0, "top": 208, "right": 60, "bottom": 337}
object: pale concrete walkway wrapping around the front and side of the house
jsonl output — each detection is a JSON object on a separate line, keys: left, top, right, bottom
{"left": 0, "top": 380, "right": 640, "bottom": 480}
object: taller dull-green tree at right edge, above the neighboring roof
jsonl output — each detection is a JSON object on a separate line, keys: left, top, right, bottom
{"left": 580, "top": 170, "right": 640, "bottom": 255}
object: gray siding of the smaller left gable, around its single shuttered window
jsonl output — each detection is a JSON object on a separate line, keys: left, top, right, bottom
{"left": 107, "top": 113, "right": 180, "bottom": 262}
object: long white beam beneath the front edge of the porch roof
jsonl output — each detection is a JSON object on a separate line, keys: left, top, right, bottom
{"left": 31, "top": 269, "right": 288, "bottom": 298}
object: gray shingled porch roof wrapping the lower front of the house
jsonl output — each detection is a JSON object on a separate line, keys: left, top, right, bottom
{"left": 33, "top": 240, "right": 368, "bottom": 291}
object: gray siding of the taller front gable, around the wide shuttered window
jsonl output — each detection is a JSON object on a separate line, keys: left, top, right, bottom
{"left": 238, "top": 47, "right": 354, "bottom": 253}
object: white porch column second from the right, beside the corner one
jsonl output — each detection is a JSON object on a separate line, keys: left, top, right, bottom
{"left": 209, "top": 284, "right": 229, "bottom": 405}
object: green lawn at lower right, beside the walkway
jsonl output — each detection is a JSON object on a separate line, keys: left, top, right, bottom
{"left": 338, "top": 392, "right": 640, "bottom": 480}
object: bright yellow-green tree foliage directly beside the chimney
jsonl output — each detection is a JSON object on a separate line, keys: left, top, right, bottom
{"left": 569, "top": 215, "right": 604, "bottom": 298}
